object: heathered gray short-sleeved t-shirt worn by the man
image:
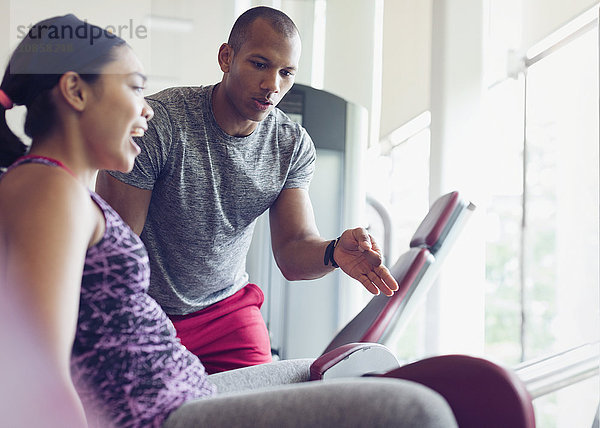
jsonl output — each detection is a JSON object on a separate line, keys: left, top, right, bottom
{"left": 110, "top": 86, "right": 315, "bottom": 315}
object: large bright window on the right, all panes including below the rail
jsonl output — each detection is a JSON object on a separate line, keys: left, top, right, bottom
{"left": 486, "top": 10, "right": 600, "bottom": 427}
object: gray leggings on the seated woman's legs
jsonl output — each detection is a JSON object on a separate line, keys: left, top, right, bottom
{"left": 163, "top": 359, "right": 456, "bottom": 428}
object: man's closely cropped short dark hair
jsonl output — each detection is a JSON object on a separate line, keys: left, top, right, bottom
{"left": 227, "top": 6, "right": 300, "bottom": 52}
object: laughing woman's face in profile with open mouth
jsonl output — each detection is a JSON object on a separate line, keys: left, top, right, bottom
{"left": 81, "top": 46, "right": 154, "bottom": 172}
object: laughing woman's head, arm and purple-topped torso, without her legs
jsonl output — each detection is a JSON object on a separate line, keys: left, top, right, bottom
{"left": 0, "top": 15, "right": 214, "bottom": 426}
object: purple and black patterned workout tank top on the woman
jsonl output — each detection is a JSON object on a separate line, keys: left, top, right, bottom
{"left": 2, "top": 157, "right": 215, "bottom": 428}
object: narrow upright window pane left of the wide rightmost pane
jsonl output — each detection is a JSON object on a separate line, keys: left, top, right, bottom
{"left": 485, "top": 78, "right": 524, "bottom": 365}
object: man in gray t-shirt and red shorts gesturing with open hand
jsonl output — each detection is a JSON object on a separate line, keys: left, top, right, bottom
{"left": 97, "top": 7, "right": 398, "bottom": 373}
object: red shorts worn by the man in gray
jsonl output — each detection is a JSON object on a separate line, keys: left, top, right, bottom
{"left": 169, "top": 284, "right": 271, "bottom": 374}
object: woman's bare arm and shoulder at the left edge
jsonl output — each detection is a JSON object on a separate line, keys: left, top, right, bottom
{"left": 0, "top": 166, "right": 99, "bottom": 426}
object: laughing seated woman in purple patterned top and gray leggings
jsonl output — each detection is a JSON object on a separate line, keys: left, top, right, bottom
{"left": 0, "top": 15, "right": 453, "bottom": 427}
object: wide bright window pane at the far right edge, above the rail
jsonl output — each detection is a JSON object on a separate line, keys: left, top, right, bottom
{"left": 524, "top": 27, "right": 600, "bottom": 358}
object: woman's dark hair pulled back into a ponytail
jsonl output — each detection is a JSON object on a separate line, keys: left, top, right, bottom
{"left": 0, "top": 15, "right": 126, "bottom": 167}
